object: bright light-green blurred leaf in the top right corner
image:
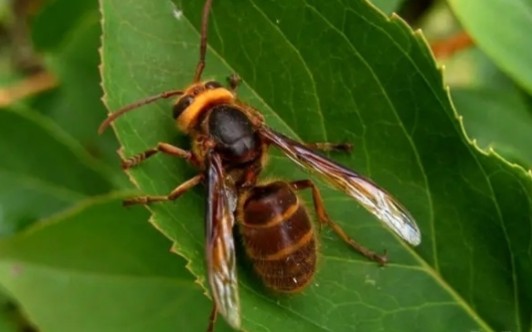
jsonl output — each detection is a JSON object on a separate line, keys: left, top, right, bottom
{"left": 449, "top": 0, "right": 532, "bottom": 93}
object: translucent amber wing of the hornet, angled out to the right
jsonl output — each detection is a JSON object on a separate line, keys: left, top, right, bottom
{"left": 260, "top": 126, "right": 421, "bottom": 245}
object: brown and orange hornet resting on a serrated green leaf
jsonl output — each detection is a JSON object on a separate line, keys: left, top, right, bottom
{"left": 99, "top": 0, "right": 421, "bottom": 330}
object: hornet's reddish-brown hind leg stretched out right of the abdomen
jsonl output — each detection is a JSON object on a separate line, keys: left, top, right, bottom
{"left": 290, "top": 180, "right": 388, "bottom": 265}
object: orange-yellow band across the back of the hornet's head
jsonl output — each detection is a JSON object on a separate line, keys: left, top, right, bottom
{"left": 177, "top": 88, "right": 235, "bottom": 133}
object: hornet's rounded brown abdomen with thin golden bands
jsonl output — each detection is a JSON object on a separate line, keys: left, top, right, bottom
{"left": 239, "top": 181, "right": 316, "bottom": 292}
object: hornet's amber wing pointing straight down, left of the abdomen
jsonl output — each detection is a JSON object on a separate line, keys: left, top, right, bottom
{"left": 206, "top": 152, "right": 240, "bottom": 329}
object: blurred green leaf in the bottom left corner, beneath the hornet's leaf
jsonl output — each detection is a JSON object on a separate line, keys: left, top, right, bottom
{"left": 0, "top": 196, "right": 225, "bottom": 332}
